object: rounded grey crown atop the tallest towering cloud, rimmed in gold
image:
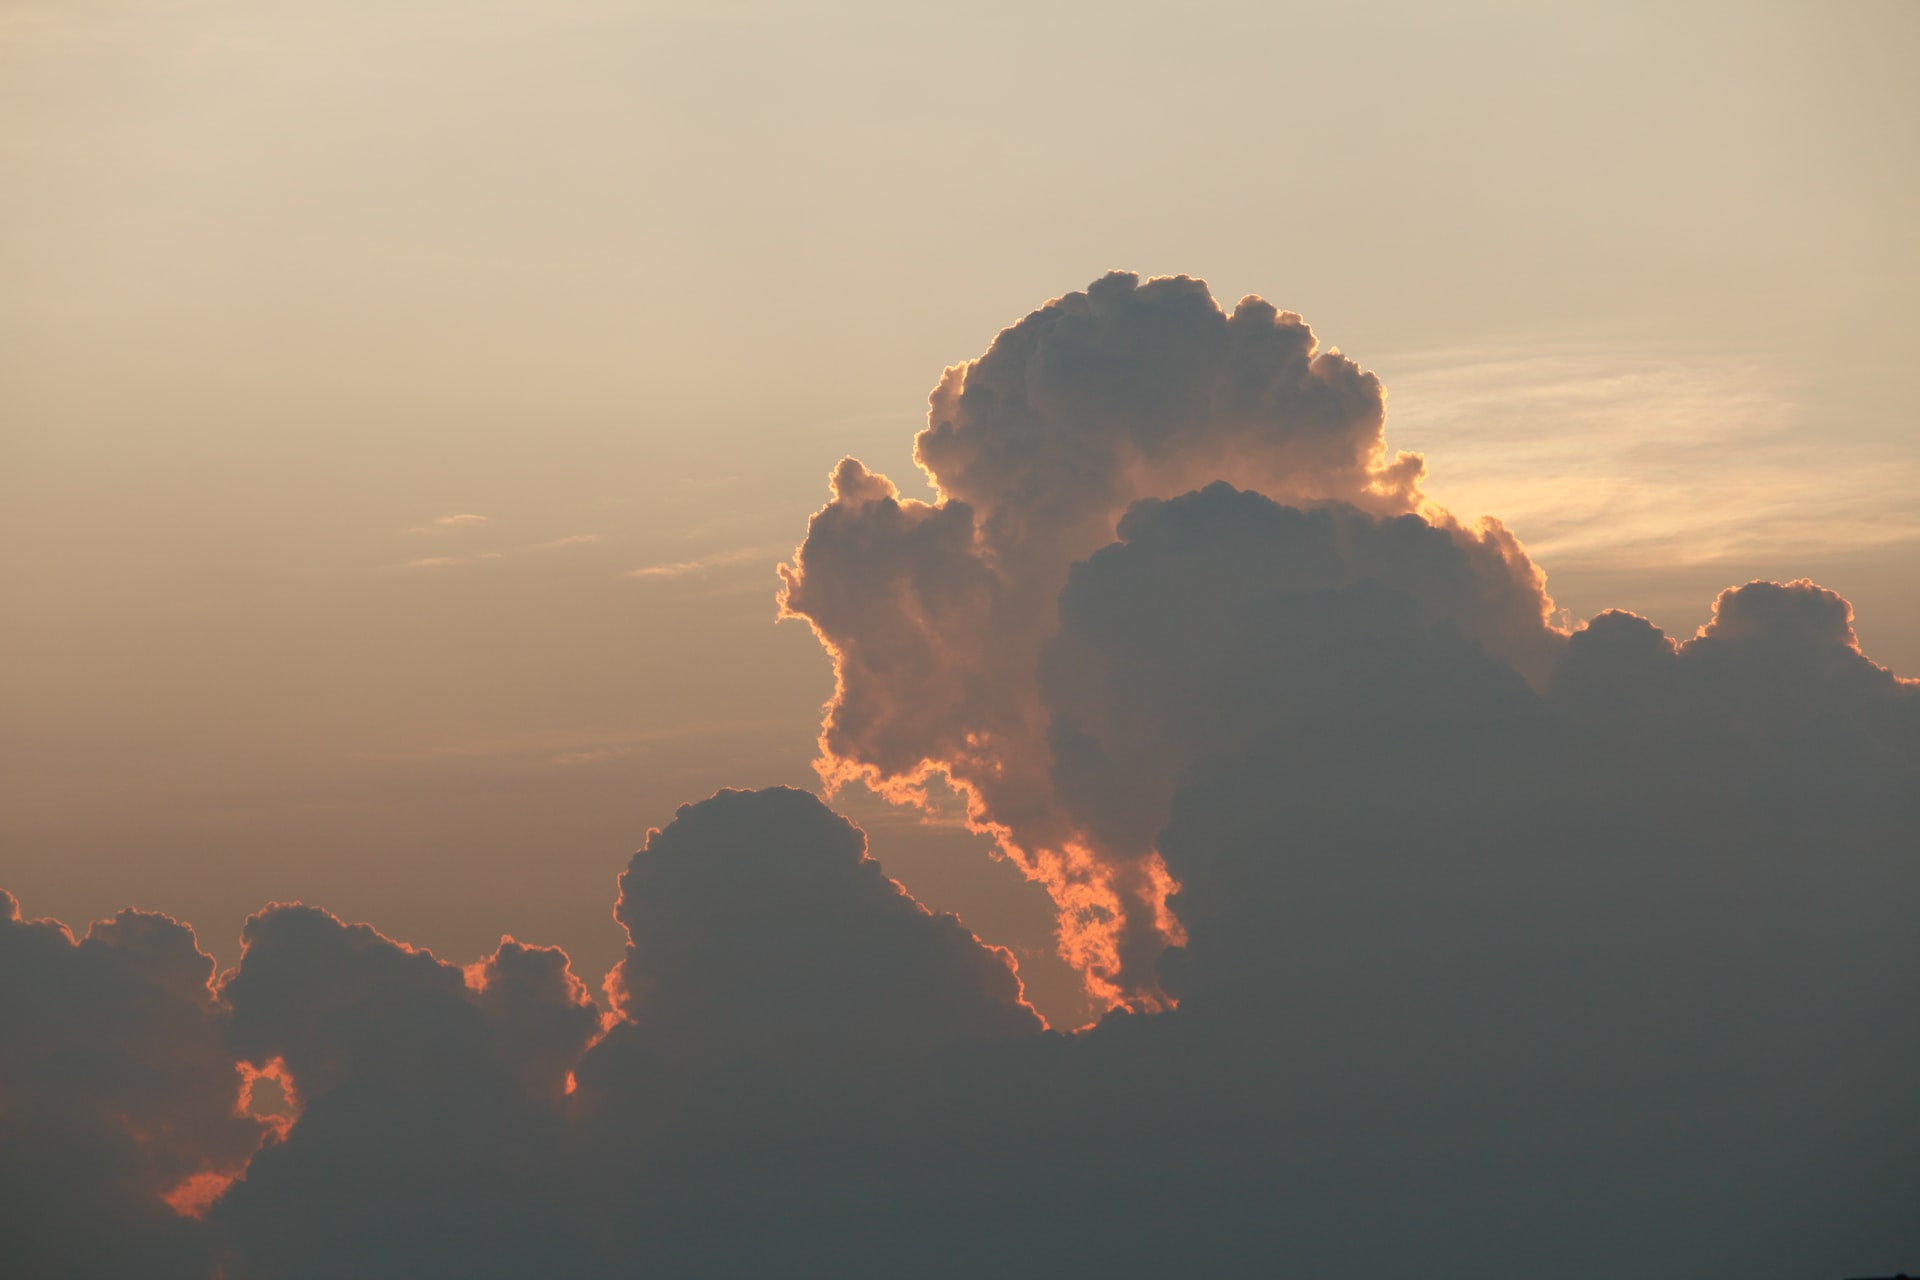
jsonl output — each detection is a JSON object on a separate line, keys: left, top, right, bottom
{"left": 914, "top": 271, "right": 1421, "bottom": 557}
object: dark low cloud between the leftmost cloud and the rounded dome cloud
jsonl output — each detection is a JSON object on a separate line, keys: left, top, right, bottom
{"left": 213, "top": 906, "right": 599, "bottom": 1276}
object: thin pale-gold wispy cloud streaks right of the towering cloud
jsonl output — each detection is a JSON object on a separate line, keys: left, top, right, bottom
{"left": 1380, "top": 342, "right": 1920, "bottom": 570}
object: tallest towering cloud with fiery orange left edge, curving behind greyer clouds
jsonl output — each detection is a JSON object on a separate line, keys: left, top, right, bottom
{"left": 781, "top": 273, "right": 1559, "bottom": 1007}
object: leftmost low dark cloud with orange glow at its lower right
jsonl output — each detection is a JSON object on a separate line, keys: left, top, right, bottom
{"left": 0, "top": 890, "right": 269, "bottom": 1276}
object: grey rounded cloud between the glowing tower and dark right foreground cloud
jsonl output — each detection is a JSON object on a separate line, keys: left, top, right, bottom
{"left": 1039, "top": 484, "right": 1565, "bottom": 973}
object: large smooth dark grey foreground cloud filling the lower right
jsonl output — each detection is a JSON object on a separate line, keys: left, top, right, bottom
{"left": 1116, "top": 583, "right": 1920, "bottom": 1276}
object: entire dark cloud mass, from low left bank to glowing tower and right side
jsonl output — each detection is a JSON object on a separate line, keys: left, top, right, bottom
{"left": 0, "top": 276, "right": 1920, "bottom": 1280}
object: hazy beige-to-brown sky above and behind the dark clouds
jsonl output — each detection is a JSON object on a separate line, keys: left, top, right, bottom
{"left": 0, "top": 0, "right": 1920, "bottom": 1015}
